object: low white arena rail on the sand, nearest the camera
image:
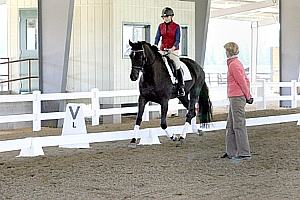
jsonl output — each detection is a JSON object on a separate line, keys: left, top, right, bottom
{"left": 0, "top": 114, "right": 300, "bottom": 157}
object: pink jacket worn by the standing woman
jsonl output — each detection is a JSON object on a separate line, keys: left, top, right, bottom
{"left": 227, "top": 57, "right": 252, "bottom": 99}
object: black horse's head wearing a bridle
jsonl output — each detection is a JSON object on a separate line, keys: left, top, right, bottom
{"left": 129, "top": 40, "right": 147, "bottom": 81}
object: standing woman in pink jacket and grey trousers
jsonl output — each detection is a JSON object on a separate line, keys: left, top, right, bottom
{"left": 221, "top": 42, "right": 253, "bottom": 160}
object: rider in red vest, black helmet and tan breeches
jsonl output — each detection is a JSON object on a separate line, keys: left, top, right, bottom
{"left": 154, "top": 7, "right": 185, "bottom": 96}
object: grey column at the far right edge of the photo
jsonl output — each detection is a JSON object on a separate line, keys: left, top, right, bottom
{"left": 279, "top": 0, "right": 300, "bottom": 107}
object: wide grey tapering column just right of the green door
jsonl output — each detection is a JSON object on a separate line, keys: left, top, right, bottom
{"left": 38, "top": 0, "right": 74, "bottom": 127}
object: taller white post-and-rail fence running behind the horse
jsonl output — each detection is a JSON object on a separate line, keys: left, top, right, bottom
{"left": 0, "top": 80, "right": 300, "bottom": 131}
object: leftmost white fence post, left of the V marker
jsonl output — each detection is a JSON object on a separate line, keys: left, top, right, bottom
{"left": 32, "top": 91, "right": 41, "bottom": 131}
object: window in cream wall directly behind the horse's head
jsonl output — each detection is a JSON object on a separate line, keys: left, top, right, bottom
{"left": 123, "top": 23, "right": 150, "bottom": 58}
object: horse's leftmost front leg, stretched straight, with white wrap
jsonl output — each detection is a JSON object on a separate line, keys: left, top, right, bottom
{"left": 128, "top": 95, "right": 148, "bottom": 148}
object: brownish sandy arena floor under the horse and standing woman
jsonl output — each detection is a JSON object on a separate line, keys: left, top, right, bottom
{"left": 0, "top": 106, "right": 300, "bottom": 200}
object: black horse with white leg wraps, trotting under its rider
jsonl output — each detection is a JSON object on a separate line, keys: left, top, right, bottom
{"left": 128, "top": 40, "right": 212, "bottom": 148}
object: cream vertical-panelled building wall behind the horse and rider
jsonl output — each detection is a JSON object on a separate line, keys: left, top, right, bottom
{"left": 6, "top": 0, "right": 195, "bottom": 103}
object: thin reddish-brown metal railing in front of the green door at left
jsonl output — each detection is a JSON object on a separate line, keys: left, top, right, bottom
{"left": 0, "top": 58, "right": 39, "bottom": 93}
